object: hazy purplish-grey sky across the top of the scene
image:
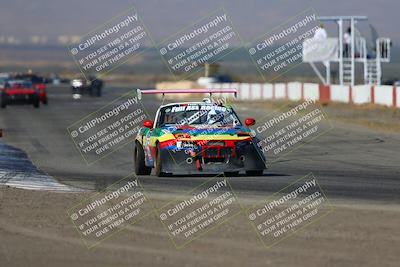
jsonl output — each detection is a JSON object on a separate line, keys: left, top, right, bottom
{"left": 0, "top": 0, "right": 400, "bottom": 45}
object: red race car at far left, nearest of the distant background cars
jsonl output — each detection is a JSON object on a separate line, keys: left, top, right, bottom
{"left": 0, "top": 80, "right": 40, "bottom": 108}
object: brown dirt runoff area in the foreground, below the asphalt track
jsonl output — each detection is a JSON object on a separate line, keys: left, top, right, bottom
{"left": 0, "top": 187, "right": 400, "bottom": 267}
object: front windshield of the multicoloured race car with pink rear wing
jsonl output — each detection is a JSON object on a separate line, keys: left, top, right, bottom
{"left": 158, "top": 103, "right": 241, "bottom": 127}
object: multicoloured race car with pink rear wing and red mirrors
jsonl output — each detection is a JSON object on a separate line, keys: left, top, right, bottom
{"left": 134, "top": 89, "right": 266, "bottom": 176}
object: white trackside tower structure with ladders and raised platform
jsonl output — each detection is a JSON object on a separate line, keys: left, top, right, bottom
{"left": 303, "top": 16, "right": 391, "bottom": 86}
